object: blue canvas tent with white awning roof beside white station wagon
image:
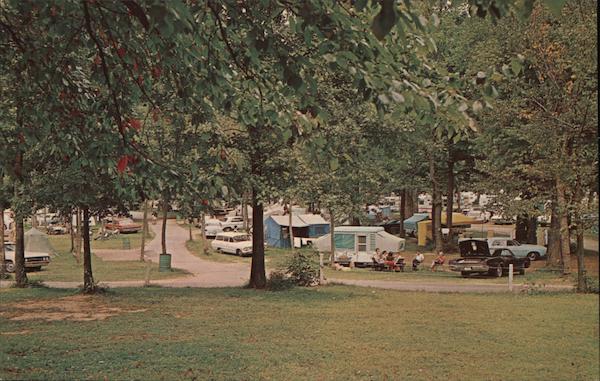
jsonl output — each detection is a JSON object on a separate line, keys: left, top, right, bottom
{"left": 265, "top": 214, "right": 329, "bottom": 248}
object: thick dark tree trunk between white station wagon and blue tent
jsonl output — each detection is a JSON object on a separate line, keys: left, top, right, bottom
{"left": 249, "top": 187, "right": 267, "bottom": 289}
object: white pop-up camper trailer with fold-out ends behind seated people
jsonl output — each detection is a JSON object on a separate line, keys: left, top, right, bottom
{"left": 313, "top": 226, "right": 406, "bottom": 266}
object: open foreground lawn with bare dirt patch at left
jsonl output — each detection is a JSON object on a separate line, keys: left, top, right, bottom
{"left": 0, "top": 286, "right": 600, "bottom": 380}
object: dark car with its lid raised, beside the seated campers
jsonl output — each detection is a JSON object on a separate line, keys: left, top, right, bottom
{"left": 449, "top": 239, "right": 531, "bottom": 278}
